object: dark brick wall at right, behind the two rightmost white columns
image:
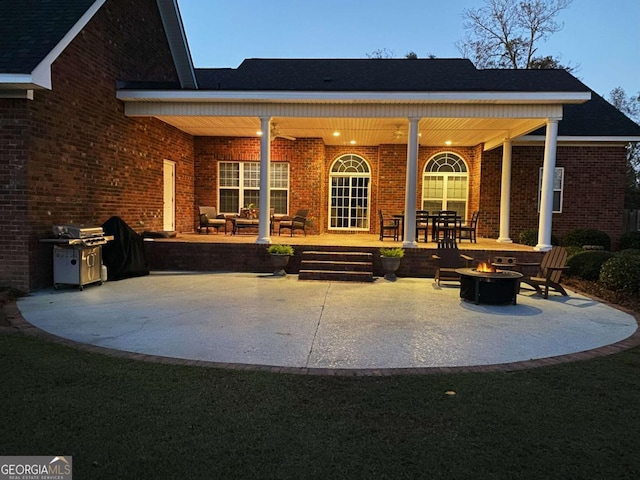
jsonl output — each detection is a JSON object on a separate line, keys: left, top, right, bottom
{"left": 480, "top": 146, "right": 626, "bottom": 246}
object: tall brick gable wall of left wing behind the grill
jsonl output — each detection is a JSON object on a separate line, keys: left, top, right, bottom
{"left": 0, "top": 0, "right": 194, "bottom": 290}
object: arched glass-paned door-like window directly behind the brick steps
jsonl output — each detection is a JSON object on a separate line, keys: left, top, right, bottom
{"left": 329, "top": 154, "right": 371, "bottom": 230}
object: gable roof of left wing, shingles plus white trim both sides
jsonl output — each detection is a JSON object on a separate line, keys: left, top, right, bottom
{"left": 0, "top": 0, "right": 196, "bottom": 90}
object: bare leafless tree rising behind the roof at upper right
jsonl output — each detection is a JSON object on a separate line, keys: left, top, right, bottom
{"left": 457, "top": 0, "right": 572, "bottom": 70}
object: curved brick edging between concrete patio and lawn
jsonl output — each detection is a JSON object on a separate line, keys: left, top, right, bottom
{"left": 0, "top": 294, "right": 640, "bottom": 377}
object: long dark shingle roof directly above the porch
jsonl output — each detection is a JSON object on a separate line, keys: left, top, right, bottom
{"left": 196, "top": 58, "right": 588, "bottom": 92}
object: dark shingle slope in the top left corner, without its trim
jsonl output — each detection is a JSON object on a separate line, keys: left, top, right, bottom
{"left": 0, "top": 0, "right": 95, "bottom": 73}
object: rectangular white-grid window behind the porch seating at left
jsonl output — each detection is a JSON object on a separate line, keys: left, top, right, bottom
{"left": 218, "top": 162, "right": 289, "bottom": 215}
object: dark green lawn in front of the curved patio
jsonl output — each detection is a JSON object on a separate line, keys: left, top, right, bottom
{"left": 0, "top": 335, "right": 640, "bottom": 480}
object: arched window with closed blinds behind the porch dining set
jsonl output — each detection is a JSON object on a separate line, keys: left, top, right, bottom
{"left": 422, "top": 152, "right": 469, "bottom": 218}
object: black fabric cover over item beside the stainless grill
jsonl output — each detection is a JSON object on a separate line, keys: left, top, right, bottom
{"left": 102, "top": 217, "right": 149, "bottom": 280}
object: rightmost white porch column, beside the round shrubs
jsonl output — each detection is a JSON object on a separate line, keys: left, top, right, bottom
{"left": 533, "top": 118, "right": 559, "bottom": 252}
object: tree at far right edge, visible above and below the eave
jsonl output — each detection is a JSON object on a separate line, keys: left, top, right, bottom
{"left": 609, "top": 87, "right": 640, "bottom": 209}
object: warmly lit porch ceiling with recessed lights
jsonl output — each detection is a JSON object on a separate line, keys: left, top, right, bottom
{"left": 156, "top": 115, "right": 545, "bottom": 148}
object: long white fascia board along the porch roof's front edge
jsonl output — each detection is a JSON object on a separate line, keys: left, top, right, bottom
{"left": 117, "top": 89, "right": 591, "bottom": 104}
